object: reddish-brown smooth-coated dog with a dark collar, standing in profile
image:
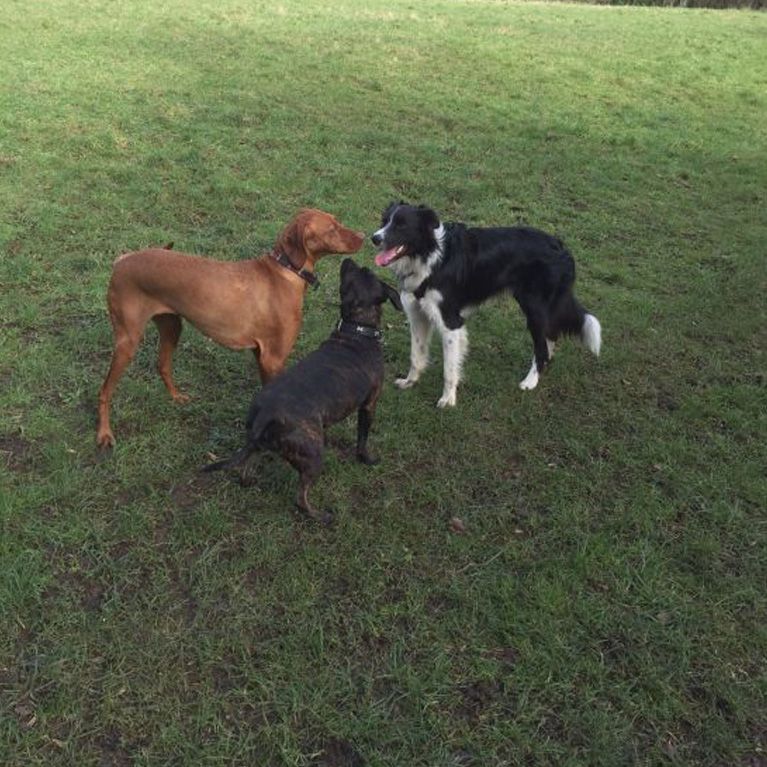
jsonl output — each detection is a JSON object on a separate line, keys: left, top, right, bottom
{"left": 96, "top": 209, "right": 364, "bottom": 448}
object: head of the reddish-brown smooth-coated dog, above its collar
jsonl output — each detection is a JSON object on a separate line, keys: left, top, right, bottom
{"left": 276, "top": 208, "right": 365, "bottom": 269}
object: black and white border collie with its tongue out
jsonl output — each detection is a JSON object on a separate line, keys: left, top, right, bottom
{"left": 371, "top": 202, "right": 602, "bottom": 407}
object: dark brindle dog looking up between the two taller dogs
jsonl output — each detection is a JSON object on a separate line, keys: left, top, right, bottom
{"left": 204, "top": 258, "right": 402, "bottom": 523}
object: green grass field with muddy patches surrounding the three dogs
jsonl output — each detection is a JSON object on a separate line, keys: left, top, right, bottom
{"left": 0, "top": 0, "right": 767, "bottom": 767}
